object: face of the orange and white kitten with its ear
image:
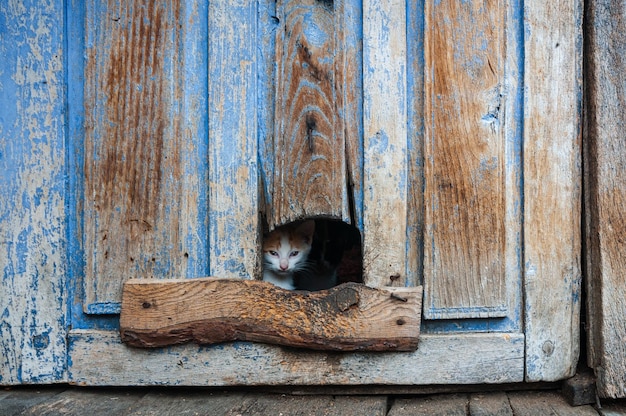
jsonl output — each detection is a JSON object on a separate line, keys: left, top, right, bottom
{"left": 263, "top": 220, "right": 315, "bottom": 275}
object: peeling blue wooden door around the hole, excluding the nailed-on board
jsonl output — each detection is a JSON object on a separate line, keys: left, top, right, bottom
{"left": 2, "top": 0, "right": 581, "bottom": 385}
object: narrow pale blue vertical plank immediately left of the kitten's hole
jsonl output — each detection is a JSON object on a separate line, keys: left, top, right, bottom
{"left": 209, "top": 0, "right": 260, "bottom": 278}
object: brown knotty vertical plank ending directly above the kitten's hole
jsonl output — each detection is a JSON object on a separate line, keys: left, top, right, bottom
{"left": 270, "top": 0, "right": 350, "bottom": 228}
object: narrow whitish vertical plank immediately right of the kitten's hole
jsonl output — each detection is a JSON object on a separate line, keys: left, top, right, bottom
{"left": 363, "top": 0, "right": 408, "bottom": 287}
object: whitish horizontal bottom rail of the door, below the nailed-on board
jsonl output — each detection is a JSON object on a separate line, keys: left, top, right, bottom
{"left": 69, "top": 330, "right": 524, "bottom": 386}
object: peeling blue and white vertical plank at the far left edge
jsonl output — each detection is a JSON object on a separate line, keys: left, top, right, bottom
{"left": 0, "top": 0, "right": 68, "bottom": 385}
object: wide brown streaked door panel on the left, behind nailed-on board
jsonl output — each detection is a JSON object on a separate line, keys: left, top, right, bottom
{"left": 84, "top": 0, "right": 206, "bottom": 313}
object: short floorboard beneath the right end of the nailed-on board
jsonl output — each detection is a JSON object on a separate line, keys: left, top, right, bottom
{"left": 388, "top": 394, "right": 468, "bottom": 416}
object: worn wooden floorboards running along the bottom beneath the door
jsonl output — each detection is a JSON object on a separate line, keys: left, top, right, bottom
{"left": 0, "top": 386, "right": 626, "bottom": 416}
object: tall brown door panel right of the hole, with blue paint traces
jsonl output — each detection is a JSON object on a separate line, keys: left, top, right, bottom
{"left": 424, "top": 0, "right": 510, "bottom": 319}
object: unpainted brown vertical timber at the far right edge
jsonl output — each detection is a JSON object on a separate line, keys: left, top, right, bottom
{"left": 585, "top": 0, "right": 626, "bottom": 398}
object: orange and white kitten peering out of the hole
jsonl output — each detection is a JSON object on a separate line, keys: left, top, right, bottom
{"left": 263, "top": 220, "right": 315, "bottom": 290}
